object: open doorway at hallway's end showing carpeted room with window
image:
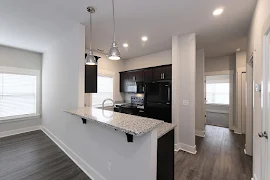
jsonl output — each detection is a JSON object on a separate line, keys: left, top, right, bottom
{"left": 204, "top": 70, "right": 235, "bottom": 130}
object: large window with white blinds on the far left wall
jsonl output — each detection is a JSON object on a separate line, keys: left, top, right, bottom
{"left": 0, "top": 67, "right": 39, "bottom": 120}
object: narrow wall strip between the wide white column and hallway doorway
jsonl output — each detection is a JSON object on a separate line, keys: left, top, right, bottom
{"left": 195, "top": 49, "right": 205, "bottom": 136}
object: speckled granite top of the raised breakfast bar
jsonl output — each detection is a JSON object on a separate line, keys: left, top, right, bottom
{"left": 64, "top": 107, "right": 163, "bottom": 136}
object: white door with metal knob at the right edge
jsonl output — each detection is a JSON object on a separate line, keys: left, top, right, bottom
{"left": 259, "top": 33, "right": 270, "bottom": 180}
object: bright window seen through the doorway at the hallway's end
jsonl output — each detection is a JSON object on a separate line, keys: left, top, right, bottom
{"left": 206, "top": 83, "right": 230, "bottom": 105}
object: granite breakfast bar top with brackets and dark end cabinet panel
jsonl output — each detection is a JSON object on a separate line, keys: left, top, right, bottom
{"left": 65, "top": 107, "right": 175, "bottom": 180}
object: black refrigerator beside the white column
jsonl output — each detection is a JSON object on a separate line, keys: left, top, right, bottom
{"left": 144, "top": 81, "right": 172, "bottom": 123}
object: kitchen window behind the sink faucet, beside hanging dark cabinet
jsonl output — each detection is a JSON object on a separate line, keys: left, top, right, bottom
{"left": 92, "top": 75, "right": 113, "bottom": 106}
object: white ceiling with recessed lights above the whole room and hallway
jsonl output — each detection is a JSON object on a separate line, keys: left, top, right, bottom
{"left": 0, "top": 0, "right": 256, "bottom": 59}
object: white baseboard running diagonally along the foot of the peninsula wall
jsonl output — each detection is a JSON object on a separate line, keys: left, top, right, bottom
{"left": 41, "top": 126, "right": 106, "bottom": 180}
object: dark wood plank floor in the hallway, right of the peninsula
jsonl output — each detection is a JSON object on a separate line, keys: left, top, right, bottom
{"left": 175, "top": 126, "right": 252, "bottom": 180}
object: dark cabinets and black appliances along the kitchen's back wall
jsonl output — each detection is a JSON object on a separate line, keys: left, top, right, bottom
{"left": 92, "top": 65, "right": 172, "bottom": 123}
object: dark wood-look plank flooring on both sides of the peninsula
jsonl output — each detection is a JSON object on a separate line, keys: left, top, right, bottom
{"left": 0, "top": 126, "right": 252, "bottom": 180}
